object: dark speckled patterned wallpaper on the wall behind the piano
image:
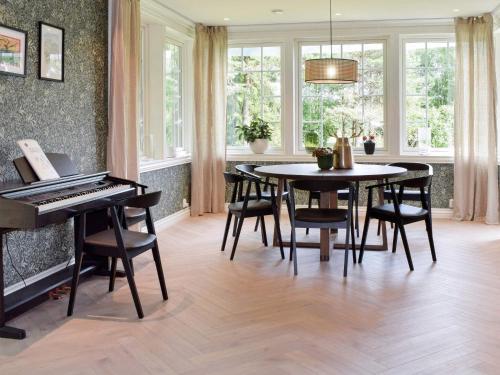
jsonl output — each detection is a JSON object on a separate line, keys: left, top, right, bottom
{"left": 0, "top": 0, "right": 108, "bottom": 286}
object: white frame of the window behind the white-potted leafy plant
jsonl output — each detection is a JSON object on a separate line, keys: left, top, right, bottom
{"left": 226, "top": 41, "right": 286, "bottom": 155}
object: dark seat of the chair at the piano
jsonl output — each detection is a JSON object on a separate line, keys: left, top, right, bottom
{"left": 85, "top": 229, "right": 156, "bottom": 250}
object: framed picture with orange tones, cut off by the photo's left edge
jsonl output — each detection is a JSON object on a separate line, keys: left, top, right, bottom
{"left": 0, "top": 24, "right": 27, "bottom": 77}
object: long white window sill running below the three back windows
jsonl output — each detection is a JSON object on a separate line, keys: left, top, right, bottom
{"left": 226, "top": 151, "right": 453, "bottom": 164}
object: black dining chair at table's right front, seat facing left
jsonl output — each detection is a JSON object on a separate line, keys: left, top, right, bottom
{"left": 359, "top": 175, "right": 436, "bottom": 271}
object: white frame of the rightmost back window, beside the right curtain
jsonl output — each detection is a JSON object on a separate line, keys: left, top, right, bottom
{"left": 399, "top": 33, "right": 455, "bottom": 158}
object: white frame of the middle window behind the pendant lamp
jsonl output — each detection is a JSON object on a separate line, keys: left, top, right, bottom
{"left": 294, "top": 37, "right": 389, "bottom": 156}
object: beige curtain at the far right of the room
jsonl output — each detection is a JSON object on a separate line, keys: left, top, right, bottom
{"left": 454, "top": 14, "right": 499, "bottom": 224}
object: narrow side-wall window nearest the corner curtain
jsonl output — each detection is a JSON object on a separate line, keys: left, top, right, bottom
{"left": 163, "top": 42, "right": 184, "bottom": 156}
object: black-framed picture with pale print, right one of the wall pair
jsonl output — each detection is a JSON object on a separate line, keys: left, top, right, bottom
{"left": 38, "top": 22, "right": 64, "bottom": 82}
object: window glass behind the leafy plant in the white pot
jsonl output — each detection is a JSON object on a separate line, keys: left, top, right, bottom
{"left": 226, "top": 46, "right": 282, "bottom": 149}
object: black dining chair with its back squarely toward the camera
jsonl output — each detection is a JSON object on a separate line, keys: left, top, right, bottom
{"left": 288, "top": 180, "right": 356, "bottom": 277}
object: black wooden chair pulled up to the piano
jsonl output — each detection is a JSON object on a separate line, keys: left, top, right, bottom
{"left": 68, "top": 191, "right": 168, "bottom": 319}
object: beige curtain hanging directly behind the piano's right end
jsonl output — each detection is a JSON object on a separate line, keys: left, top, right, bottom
{"left": 107, "top": 0, "right": 141, "bottom": 180}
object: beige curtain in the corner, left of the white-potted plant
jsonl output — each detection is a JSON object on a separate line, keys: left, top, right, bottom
{"left": 191, "top": 25, "right": 227, "bottom": 216}
